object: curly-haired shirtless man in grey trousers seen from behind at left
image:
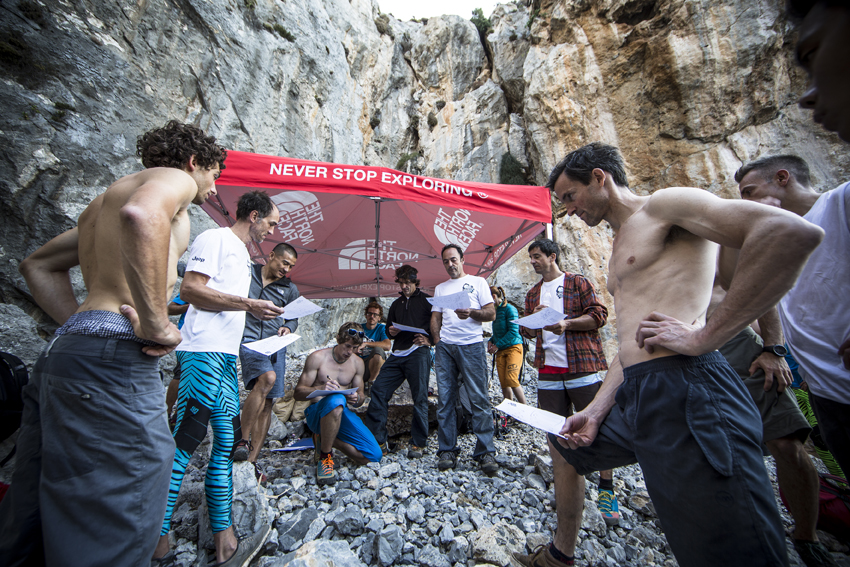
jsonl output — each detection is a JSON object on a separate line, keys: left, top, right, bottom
{"left": 0, "top": 121, "right": 227, "bottom": 566}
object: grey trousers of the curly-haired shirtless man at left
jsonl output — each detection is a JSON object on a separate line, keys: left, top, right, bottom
{"left": 0, "top": 335, "right": 174, "bottom": 566}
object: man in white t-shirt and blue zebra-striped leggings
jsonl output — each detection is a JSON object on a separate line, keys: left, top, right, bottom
{"left": 154, "top": 191, "right": 283, "bottom": 566}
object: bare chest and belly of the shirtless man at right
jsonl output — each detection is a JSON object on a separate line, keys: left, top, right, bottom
{"left": 608, "top": 193, "right": 717, "bottom": 367}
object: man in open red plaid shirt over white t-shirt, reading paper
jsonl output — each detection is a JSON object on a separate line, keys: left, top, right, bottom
{"left": 520, "top": 239, "right": 620, "bottom": 567}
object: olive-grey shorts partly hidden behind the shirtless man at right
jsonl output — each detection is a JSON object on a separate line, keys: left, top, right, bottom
{"left": 719, "top": 327, "right": 812, "bottom": 443}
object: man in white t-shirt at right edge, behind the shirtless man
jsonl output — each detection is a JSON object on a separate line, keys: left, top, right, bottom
{"left": 735, "top": 155, "right": 850, "bottom": 484}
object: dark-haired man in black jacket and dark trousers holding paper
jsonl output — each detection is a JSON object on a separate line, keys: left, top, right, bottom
{"left": 365, "top": 264, "right": 432, "bottom": 459}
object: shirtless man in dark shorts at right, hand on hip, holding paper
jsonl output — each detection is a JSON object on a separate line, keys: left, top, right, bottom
{"left": 512, "top": 143, "right": 823, "bottom": 566}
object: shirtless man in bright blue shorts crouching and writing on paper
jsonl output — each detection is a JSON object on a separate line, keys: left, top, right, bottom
{"left": 295, "top": 323, "right": 383, "bottom": 484}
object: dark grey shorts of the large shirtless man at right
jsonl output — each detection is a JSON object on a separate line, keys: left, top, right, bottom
{"left": 549, "top": 351, "right": 788, "bottom": 567}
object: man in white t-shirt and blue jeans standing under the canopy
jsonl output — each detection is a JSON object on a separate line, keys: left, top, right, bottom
{"left": 431, "top": 244, "right": 499, "bottom": 475}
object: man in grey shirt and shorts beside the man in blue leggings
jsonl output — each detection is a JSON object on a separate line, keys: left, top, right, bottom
{"left": 233, "top": 242, "right": 298, "bottom": 478}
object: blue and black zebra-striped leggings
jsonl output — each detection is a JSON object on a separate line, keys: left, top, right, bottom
{"left": 161, "top": 351, "right": 242, "bottom": 535}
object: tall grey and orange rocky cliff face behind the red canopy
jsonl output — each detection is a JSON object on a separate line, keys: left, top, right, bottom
{"left": 0, "top": 0, "right": 850, "bottom": 364}
